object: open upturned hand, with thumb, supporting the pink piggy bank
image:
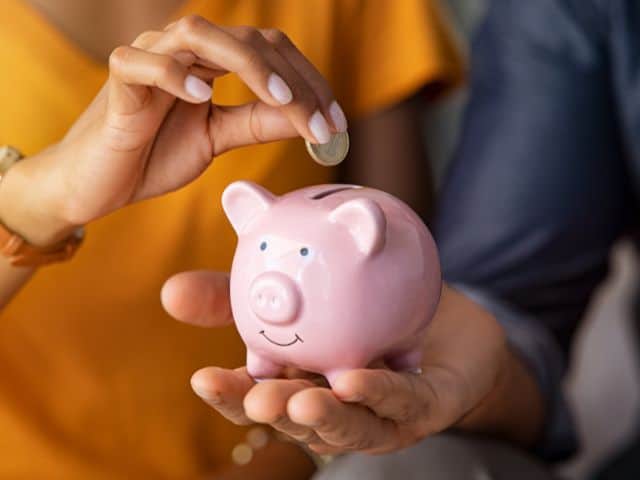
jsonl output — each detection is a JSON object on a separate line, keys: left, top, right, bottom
{"left": 163, "top": 272, "right": 542, "bottom": 454}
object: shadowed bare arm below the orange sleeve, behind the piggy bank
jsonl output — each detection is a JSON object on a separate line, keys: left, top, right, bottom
{"left": 342, "top": 94, "right": 433, "bottom": 218}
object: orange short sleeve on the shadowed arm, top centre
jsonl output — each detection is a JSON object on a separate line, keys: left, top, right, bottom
{"left": 335, "top": 0, "right": 464, "bottom": 117}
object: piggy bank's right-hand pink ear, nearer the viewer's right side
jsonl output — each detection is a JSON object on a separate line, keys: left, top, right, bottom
{"left": 329, "top": 198, "right": 387, "bottom": 256}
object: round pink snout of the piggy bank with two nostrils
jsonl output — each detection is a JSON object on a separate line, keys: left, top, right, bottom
{"left": 249, "top": 272, "right": 300, "bottom": 324}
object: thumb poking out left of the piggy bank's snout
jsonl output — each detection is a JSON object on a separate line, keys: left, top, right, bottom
{"left": 160, "top": 271, "right": 233, "bottom": 327}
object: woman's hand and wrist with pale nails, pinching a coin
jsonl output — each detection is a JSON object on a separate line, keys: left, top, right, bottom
{"left": 0, "top": 16, "right": 346, "bottom": 243}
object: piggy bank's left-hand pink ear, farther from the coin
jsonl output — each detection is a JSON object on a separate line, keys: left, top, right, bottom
{"left": 222, "top": 181, "right": 276, "bottom": 234}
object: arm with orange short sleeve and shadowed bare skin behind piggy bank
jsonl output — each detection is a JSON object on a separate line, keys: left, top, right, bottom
{"left": 333, "top": 0, "right": 466, "bottom": 219}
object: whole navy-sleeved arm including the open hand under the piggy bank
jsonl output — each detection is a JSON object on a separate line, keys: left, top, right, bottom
{"left": 172, "top": 0, "right": 630, "bottom": 459}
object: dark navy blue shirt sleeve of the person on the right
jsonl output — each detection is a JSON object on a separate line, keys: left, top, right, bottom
{"left": 435, "top": 0, "right": 631, "bottom": 459}
